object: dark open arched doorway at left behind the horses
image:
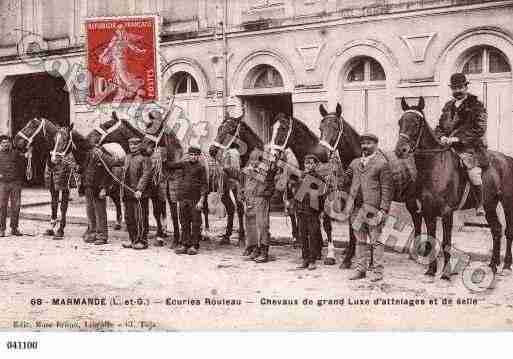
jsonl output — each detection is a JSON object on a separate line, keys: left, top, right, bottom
{"left": 11, "top": 74, "right": 70, "bottom": 186}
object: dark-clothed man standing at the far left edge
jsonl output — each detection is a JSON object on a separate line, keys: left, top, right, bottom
{"left": 0, "top": 135, "right": 25, "bottom": 237}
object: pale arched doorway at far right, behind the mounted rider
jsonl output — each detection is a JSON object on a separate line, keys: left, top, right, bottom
{"left": 456, "top": 46, "right": 513, "bottom": 154}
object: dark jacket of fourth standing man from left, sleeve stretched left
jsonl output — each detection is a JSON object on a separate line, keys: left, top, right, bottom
{"left": 165, "top": 160, "right": 208, "bottom": 202}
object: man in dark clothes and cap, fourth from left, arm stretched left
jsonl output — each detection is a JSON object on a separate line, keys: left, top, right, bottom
{"left": 165, "top": 146, "right": 208, "bottom": 255}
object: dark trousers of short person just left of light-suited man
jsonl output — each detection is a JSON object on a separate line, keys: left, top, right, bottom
{"left": 297, "top": 211, "right": 322, "bottom": 263}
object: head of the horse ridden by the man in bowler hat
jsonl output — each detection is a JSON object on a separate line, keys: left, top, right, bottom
{"left": 395, "top": 96, "right": 427, "bottom": 158}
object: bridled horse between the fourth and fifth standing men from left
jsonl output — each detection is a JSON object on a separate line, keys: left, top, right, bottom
{"left": 209, "top": 114, "right": 264, "bottom": 244}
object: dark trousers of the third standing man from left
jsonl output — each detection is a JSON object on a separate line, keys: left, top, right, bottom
{"left": 124, "top": 197, "right": 148, "bottom": 244}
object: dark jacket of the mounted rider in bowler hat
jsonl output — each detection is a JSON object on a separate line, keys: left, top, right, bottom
{"left": 435, "top": 94, "right": 487, "bottom": 166}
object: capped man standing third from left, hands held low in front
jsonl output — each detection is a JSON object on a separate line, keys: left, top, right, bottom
{"left": 122, "top": 137, "right": 153, "bottom": 249}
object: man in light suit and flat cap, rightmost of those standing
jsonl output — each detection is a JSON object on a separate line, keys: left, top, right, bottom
{"left": 344, "top": 134, "right": 393, "bottom": 282}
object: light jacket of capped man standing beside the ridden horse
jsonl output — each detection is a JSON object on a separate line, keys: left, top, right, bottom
{"left": 346, "top": 150, "right": 394, "bottom": 213}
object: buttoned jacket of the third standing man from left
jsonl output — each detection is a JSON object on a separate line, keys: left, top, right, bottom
{"left": 123, "top": 151, "right": 153, "bottom": 200}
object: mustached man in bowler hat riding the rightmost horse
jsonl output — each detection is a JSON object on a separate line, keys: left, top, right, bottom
{"left": 435, "top": 73, "right": 489, "bottom": 216}
